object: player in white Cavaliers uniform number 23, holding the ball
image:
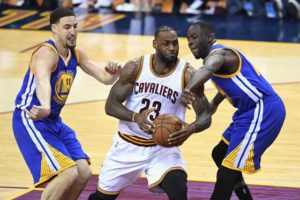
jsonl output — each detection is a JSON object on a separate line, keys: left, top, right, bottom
{"left": 89, "top": 26, "right": 211, "bottom": 200}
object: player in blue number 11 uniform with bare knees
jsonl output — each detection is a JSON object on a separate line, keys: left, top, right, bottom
{"left": 13, "top": 8, "right": 121, "bottom": 200}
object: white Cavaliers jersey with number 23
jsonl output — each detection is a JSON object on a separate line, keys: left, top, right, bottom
{"left": 119, "top": 55, "right": 187, "bottom": 139}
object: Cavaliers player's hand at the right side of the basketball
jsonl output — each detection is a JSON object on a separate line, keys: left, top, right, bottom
{"left": 168, "top": 122, "right": 195, "bottom": 146}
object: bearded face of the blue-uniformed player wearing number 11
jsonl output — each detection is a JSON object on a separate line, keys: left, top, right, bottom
{"left": 55, "top": 16, "right": 77, "bottom": 48}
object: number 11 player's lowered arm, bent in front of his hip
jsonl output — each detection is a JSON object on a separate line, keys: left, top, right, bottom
{"left": 25, "top": 46, "right": 58, "bottom": 120}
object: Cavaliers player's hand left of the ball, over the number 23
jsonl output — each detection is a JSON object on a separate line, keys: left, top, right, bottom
{"left": 135, "top": 108, "right": 155, "bottom": 134}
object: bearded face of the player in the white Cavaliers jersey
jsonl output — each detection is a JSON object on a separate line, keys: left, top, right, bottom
{"left": 154, "top": 31, "right": 179, "bottom": 62}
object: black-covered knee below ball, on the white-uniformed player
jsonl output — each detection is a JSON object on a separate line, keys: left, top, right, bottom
{"left": 160, "top": 170, "right": 187, "bottom": 200}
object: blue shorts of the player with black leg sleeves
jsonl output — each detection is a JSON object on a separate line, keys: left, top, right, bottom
{"left": 222, "top": 97, "right": 286, "bottom": 173}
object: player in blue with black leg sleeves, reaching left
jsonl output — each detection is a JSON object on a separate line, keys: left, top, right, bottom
{"left": 178, "top": 22, "right": 285, "bottom": 200}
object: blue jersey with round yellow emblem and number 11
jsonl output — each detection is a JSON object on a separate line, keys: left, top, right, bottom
{"left": 15, "top": 40, "right": 79, "bottom": 118}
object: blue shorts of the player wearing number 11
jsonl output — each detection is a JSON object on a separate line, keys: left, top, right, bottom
{"left": 12, "top": 109, "right": 89, "bottom": 185}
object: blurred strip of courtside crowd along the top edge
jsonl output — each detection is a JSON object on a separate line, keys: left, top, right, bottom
{"left": 0, "top": 0, "right": 300, "bottom": 20}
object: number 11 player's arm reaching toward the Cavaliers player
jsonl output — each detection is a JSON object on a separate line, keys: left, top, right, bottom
{"left": 78, "top": 49, "right": 122, "bottom": 85}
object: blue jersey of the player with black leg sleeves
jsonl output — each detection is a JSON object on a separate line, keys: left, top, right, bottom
{"left": 211, "top": 45, "right": 277, "bottom": 111}
